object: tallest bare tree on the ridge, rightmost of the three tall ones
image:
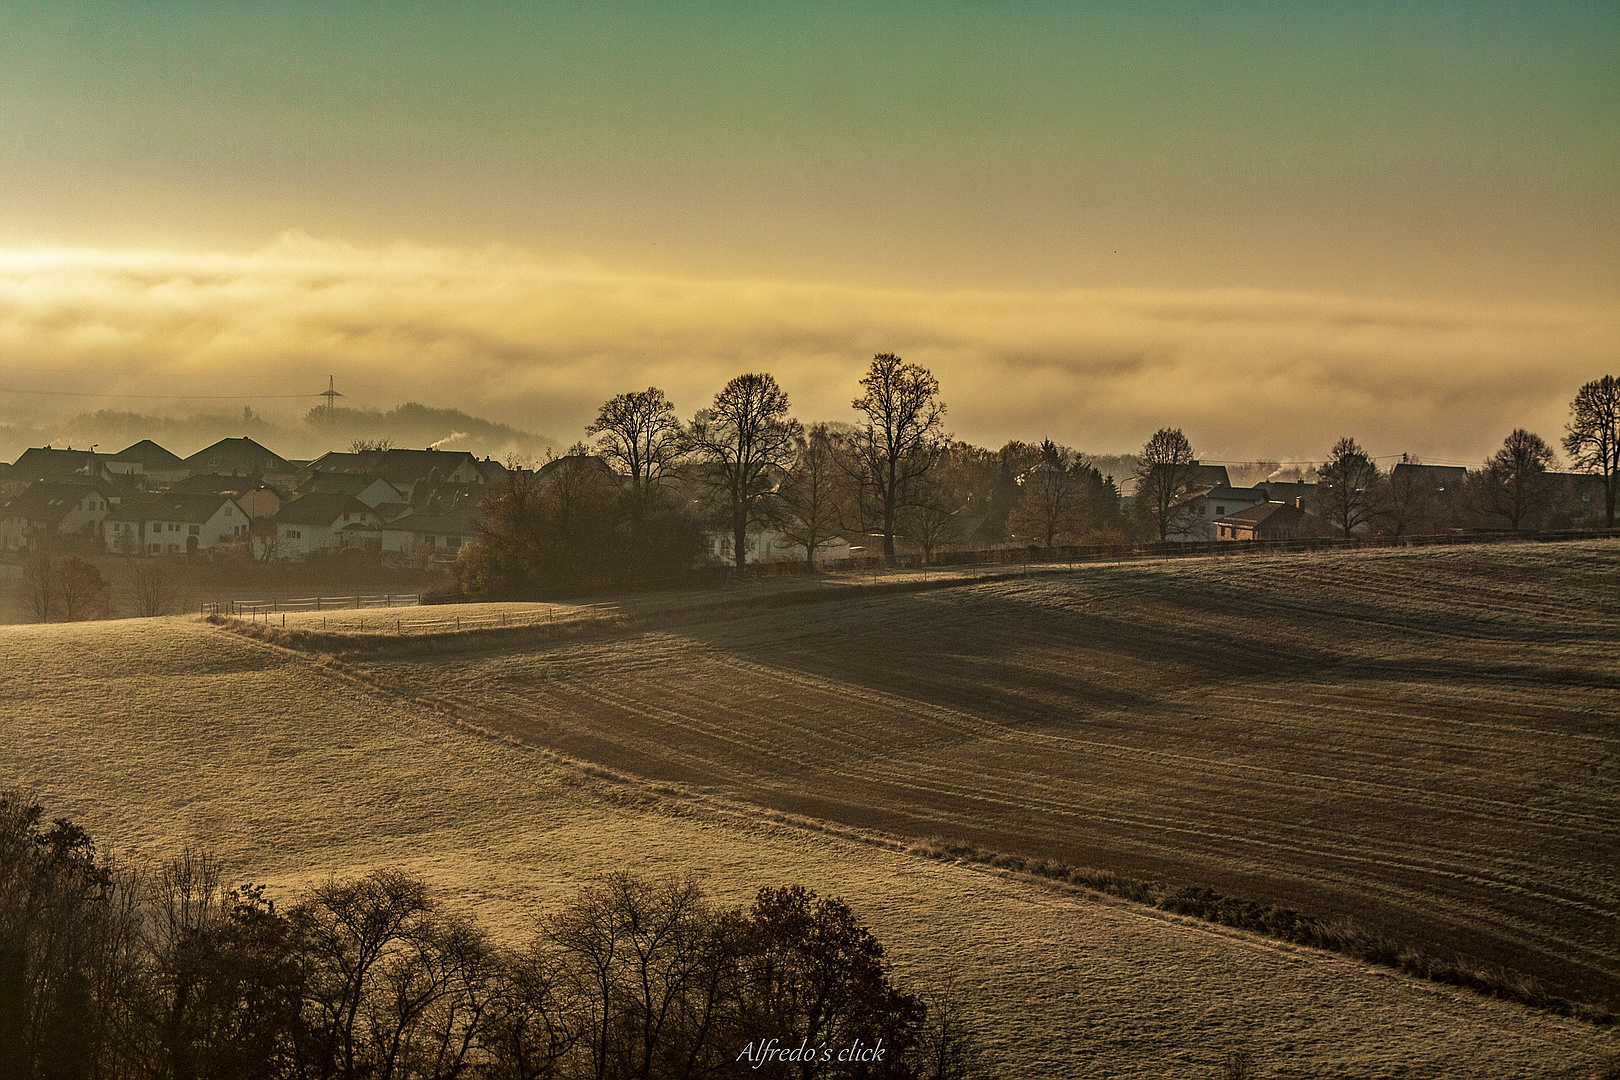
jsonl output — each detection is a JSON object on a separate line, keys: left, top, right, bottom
{"left": 851, "top": 353, "right": 949, "bottom": 555}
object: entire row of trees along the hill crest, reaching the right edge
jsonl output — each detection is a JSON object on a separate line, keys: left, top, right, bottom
{"left": 457, "top": 367, "right": 1620, "bottom": 596}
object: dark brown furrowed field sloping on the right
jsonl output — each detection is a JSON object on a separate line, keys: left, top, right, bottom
{"left": 325, "top": 541, "right": 1620, "bottom": 1009}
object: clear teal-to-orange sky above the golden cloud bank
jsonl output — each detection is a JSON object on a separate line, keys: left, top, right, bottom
{"left": 0, "top": 3, "right": 1620, "bottom": 300}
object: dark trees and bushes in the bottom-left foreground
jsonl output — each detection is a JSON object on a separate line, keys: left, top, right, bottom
{"left": 0, "top": 792, "right": 987, "bottom": 1080}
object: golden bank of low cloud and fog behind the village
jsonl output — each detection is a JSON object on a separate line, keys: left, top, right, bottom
{"left": 0, "top": 233, "right": 1620, "bottom": 461}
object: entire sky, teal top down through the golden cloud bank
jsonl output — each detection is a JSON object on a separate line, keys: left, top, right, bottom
{"left": 0, "top": 0, "right": 1620, "bottom": 461}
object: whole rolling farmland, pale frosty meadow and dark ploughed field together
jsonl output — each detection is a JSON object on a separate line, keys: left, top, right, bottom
{"left": 0, "top": 546, "right": 1620, "bottom": 1077}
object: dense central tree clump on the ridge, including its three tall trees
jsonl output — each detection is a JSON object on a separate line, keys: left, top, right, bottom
{"left": 458, "top": 353, "right": 1124, "bottom": 596}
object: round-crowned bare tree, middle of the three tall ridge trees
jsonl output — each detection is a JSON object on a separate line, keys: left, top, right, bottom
{"left": 690, "top": 374, "right": 804, "bottom": 570}
